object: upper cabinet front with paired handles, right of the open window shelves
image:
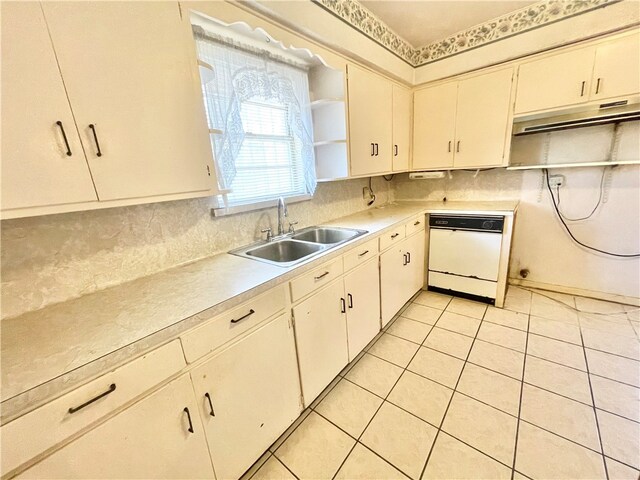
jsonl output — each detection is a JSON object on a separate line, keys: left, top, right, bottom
{"left": 348, "top": 65, "right": 393, "bottom": 176}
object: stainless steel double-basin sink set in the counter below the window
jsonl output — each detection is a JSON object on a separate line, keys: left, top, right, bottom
{"left": 229, "top": 227, "right": 368, "bottom": 267}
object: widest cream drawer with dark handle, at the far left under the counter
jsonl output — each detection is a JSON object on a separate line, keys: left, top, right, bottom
{"left": 0, "top": 340, "right": 185, "bottom": 477}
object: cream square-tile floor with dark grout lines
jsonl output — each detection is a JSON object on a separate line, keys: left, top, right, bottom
{"left": 244, "top": 287, "right": 640, "bottom": 480}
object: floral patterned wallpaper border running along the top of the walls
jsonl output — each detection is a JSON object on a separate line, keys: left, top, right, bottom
{"left": 311, "top": 0, "right": 622, "bottom": 67}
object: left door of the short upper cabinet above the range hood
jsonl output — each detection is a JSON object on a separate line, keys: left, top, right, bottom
{"left": 515, "top": 47, "right": 595, "bottom": 114}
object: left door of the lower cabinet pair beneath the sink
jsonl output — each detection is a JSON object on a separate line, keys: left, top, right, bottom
{"left": 293, "top": 279, "right": 349, "bottom": 406}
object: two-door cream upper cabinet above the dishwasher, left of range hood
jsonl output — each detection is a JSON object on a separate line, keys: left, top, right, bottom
{"left": 412, "top": 68, "right": 513, "bottom": 170}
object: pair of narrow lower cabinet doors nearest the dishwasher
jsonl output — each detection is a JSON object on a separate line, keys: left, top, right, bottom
{"left": 380, "top": 230, "right": 425, "bottom": 327}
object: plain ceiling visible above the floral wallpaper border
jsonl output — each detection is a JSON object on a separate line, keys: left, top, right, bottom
{"left": 360, "top": 0, "right": 537, "bottom": 48}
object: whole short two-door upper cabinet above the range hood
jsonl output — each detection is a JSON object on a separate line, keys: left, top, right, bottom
{"left": 515, "top": 33, "right": 640, "bottom": 115}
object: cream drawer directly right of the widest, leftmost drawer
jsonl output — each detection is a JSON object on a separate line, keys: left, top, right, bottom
{"left": 180, "top": 285, "right": 286, "bottom": 363}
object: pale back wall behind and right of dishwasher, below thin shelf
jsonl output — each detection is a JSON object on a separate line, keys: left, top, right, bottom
{"left": 393, "top": 165, "right": 640, "bottom": 298}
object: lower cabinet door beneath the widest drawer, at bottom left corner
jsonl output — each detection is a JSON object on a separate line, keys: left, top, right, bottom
{"left": 17, "top": 375, "right": 215, "bottom": 479}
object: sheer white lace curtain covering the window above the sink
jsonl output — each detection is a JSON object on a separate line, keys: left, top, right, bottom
{"left": 193, "top": 26, "right": 317, "bottom": 206}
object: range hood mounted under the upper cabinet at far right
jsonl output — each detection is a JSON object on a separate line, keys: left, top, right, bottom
{"left": 513, "top": 99, "right": 640, "bottom": 136}
